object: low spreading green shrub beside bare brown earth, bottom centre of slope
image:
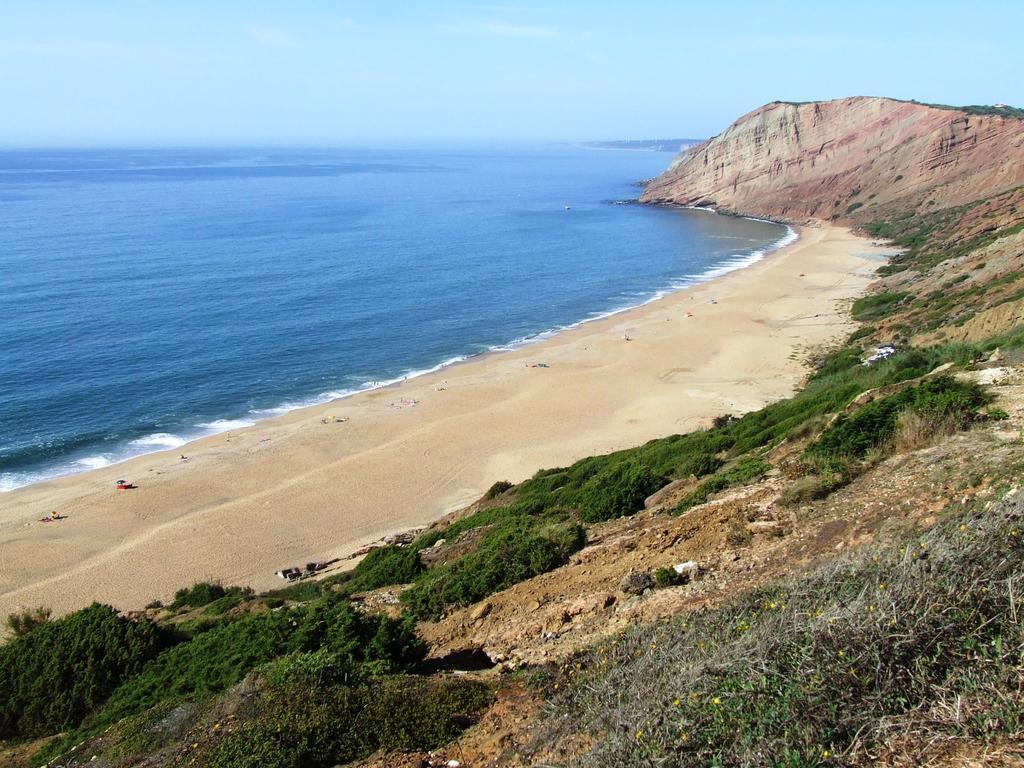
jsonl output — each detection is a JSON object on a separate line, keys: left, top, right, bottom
{"left": 401, "top": 516, "right": 586, "bottom": 618}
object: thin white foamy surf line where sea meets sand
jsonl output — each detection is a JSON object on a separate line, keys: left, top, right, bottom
{"left": 0, "top": 218, "right": 800, "bottom": 493}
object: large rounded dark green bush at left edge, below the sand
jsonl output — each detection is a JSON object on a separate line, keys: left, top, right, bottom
{"left": 0, "top": 603, "right": 165, "bottom": 738}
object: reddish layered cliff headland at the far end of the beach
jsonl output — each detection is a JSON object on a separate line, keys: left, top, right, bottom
{"left": 641, "top": 97, "right": 1024, "bottom": 222}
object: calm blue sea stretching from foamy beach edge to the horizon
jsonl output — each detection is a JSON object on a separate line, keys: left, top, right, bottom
{"left": 0, "top": 146, "right": 786, "bottom": 490}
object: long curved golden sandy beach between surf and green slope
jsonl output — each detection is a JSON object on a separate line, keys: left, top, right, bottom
{"left": 0, "top": 226, "right": 880, "bottom": 615}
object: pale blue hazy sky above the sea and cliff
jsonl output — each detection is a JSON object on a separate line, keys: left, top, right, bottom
{"left": 0, "top": 0, "right": 1024, "bottom": 146}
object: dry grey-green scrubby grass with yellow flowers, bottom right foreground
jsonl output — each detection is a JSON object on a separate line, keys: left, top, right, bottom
{"left": 534, "top": 496, "right": 1024, "bottom": 768}
